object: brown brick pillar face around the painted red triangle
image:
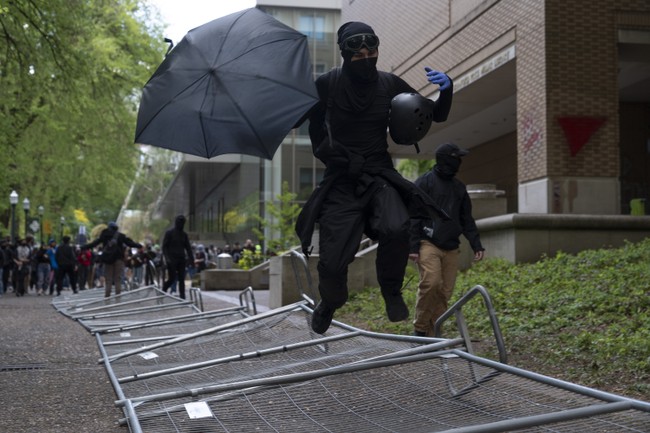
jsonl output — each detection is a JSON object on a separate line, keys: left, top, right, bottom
{"left": 540, "top": 0, "right": 619, "bottom": 180}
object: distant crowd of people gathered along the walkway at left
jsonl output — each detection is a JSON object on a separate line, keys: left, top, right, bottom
{"left": 0, "top": 224, "right": 260, "bottom": 296}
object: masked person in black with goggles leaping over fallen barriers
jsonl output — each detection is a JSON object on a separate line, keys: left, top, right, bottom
{"left": 296, "top": 22, "right": 453, "bottom": 334}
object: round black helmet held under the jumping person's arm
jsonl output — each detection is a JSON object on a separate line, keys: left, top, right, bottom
{"left": 388, "top": 92, "right": 433, "bottom": 145}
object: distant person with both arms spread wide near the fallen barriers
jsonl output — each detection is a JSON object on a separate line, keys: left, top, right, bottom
{"left": 81, "top": 221, "right": 142, "bottom": 298}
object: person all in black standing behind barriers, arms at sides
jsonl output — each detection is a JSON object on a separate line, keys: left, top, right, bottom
{"left": 162, "top": 215, "right": 194, "bottom": 299}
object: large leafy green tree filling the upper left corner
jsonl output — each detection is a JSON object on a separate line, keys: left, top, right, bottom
{"left": 0, "top": 0, "right": 166, "bottom": 230}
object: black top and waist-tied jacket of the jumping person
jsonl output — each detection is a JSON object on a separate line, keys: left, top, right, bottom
{"left": 296, "top": 69, "right": 453, "bottom": 255}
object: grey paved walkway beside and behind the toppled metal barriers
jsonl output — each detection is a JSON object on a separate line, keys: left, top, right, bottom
{"left": 0, "top": 291, "right": 268, "bottom": 433}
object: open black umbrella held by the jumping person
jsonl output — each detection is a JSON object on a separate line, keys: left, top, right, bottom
{"left": 135, "top": 8, "right": 318, "bottom": 159}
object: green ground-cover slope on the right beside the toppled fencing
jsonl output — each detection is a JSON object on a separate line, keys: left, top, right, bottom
{"left": 335, "top": 238, "right": 650, "bottom": 401}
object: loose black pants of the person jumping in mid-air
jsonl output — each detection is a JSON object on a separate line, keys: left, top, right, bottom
{"left": 318, "top": 179, "right": 410, "bottom": 308}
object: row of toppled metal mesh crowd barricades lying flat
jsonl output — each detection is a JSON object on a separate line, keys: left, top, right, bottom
{"left": 56, "top": 253, "right": 650, "bottom": 433}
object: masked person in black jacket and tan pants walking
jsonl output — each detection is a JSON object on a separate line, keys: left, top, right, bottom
{"left": 409, "top": 143, "right": 484, "bottom": 337}
